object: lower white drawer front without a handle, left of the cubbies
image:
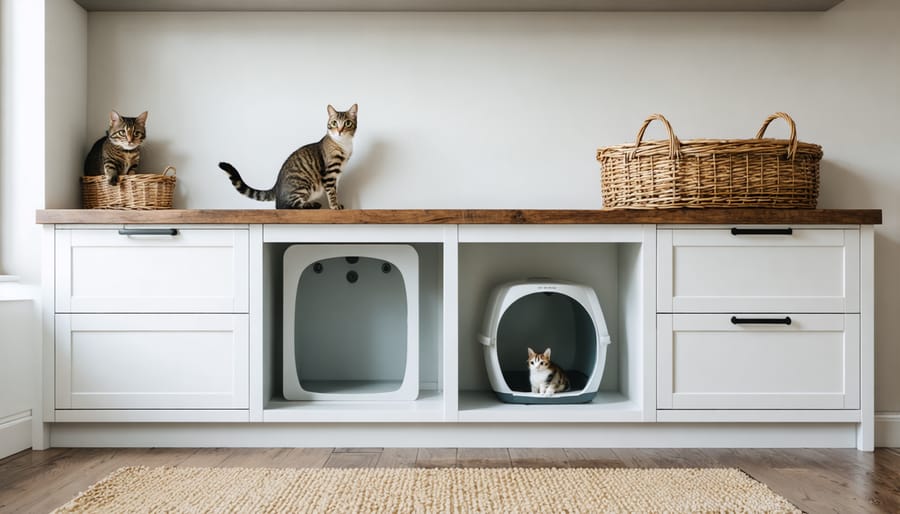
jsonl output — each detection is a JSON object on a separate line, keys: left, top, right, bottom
{"left": 56, "top": 314, "right": 249, "bottom": 409}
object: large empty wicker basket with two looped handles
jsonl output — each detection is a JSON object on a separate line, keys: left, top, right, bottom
{"left": 597, "top": 112, "right": 822, "bottom": 209}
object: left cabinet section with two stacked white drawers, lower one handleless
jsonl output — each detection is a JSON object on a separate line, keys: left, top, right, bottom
{"left": 53, "top": 226, "right": 250, "bottom": 421}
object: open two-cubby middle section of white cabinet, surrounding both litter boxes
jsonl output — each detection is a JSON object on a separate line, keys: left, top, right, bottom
{"left": 261, "top": 226, "right": 655, "bottom": 423}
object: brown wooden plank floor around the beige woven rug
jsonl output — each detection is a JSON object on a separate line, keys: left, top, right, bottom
{"left": 0, "top": 448, "right": 900, "bottom": 513}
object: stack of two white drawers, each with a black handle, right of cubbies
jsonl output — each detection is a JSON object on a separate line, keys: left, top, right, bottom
{"left": 657, "top": 226, "right": 861, "bottom": 410}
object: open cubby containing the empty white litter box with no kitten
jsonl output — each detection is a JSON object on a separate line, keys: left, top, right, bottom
{"left": 263, "top": 242, "right": 443, "bottom": 421}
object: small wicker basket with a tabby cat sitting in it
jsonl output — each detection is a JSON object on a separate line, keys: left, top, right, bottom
{"left": 81, "top": 166, "right": 175, "bottom": 210}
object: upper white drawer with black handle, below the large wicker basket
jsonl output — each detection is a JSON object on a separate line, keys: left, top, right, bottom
{"left": 657, "top": 228, "right": 859, "bottom": 313}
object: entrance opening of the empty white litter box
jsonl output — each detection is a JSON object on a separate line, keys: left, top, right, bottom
{"left": 294, "top": 256, "right": 407, "bottom": 394}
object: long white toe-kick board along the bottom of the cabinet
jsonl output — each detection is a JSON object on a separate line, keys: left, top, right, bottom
{"left": 50, "top": 423, "right": 856, "bottom": 448}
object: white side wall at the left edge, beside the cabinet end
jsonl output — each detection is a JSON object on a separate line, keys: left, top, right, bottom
{"left": 0, "top": 0, "right": 87, "bottom": 456}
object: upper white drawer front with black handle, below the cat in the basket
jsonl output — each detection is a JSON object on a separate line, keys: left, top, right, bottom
{"left": 56, "top": 229, "right": 249, "bottom": 312}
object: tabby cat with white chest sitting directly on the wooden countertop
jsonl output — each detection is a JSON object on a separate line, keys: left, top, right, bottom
{"left": 219, "top": 104, "right": 357, "bottom": 209}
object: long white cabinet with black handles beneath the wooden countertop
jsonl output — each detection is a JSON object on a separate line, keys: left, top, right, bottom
{"left": 42, "top": 216, "right": 874, "bottom": 449}
